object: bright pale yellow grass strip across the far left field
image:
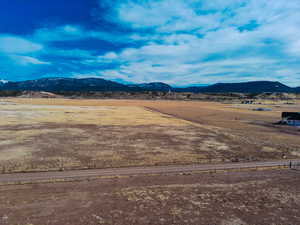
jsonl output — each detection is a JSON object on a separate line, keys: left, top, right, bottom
{"left": 0, "top": 104, "right": 190, "bottom": 126}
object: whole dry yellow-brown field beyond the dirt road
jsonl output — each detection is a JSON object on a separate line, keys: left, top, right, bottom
{"left": 0, "top": 98, "right": 300, "bottom": 173}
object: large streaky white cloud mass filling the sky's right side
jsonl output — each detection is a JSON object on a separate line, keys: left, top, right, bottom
{"left": 90, "top": 0, "right": 300, "bottom": 85}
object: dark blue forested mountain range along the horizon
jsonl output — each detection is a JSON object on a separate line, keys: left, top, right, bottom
{"left": 0, "top": 78, "right": 300, "bottom": 93}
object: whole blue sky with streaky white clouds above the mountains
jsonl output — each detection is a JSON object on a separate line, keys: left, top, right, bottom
{"left": 0, "top": 0, "right": 300, "bottom": 87}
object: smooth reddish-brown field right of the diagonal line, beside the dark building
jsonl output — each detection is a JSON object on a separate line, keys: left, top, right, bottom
{"left": 143, "top": 102, "right": 300, "bottom": 158}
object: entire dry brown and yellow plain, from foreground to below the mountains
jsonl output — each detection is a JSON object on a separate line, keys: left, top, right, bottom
{"left": 0, "top": 98, "right": 300, "bottom": 225}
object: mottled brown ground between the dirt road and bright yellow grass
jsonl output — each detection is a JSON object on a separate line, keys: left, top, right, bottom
{"left": 0, "top": 120, "right": 295, "bottom": 173}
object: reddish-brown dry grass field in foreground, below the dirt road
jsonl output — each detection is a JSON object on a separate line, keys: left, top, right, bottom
{"left": 0, "top": 170, "right": 300, "bottom": 225}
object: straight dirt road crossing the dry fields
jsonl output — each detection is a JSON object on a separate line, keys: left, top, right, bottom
{"left": 0, "top": 160, "right": 300, "bottom": 185}
